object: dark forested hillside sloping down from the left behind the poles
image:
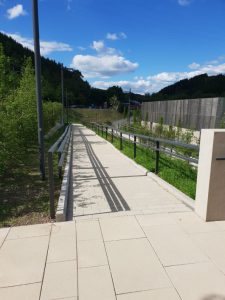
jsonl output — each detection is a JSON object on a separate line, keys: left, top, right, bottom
{"left": 0, "top": 33, "right": 143, "bottom": 107}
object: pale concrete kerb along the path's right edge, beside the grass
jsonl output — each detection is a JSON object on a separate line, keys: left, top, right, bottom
{"left": 88, "top": 124, "right": 195, "bottom": 210}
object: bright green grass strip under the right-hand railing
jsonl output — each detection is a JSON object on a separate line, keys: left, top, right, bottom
{"left": 93, "top": 126, "right": 197, "bottom": 199}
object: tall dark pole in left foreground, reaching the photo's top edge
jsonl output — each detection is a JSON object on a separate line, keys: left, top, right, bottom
{"left": 33, "top": 0, "right": 45, "bottom": 180}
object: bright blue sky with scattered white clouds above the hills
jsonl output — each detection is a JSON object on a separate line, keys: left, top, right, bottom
{"left": 0, "top": 0, "right": 225, "bottom": 93}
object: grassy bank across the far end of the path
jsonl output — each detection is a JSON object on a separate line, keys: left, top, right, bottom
{"left": 69, "top": 108, "right": 124, "bottom": 124}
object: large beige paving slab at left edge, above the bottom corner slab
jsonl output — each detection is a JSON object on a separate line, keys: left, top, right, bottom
{"left": 0, "top": 236, "right": 49, "bottom": 287}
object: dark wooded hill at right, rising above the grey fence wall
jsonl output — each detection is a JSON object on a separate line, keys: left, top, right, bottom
{"left": 144, "top": 74, "right": 225, "bottom": 101}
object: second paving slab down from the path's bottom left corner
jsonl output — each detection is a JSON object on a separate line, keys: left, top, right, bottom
{"left": 78, "top": 240, "right": 108, "bottom": 268}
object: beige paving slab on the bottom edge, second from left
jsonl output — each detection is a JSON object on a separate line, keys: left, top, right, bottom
{"left": 41, "top": 261, "right": 77, "bottom": 300}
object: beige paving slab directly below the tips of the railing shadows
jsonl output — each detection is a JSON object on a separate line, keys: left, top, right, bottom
{"left": 100, "top": 216, "right": 145, "bottom": 241}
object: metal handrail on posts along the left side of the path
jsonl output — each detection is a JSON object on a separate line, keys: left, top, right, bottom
{"left": 48, "top": 126, "right": 71, "bottom": 219}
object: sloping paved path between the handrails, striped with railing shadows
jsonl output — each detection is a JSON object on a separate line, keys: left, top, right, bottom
{"left": 73, "top": 125, "right": 190, "bottom": 218}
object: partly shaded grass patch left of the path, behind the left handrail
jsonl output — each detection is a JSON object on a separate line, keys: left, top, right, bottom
{"left": 0, "top": 129, "right": 63, "bottom": 227}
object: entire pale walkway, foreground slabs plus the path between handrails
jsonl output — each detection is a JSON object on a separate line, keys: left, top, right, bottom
{"left": 0, "top": 123, "right": 225, "bottom": 300}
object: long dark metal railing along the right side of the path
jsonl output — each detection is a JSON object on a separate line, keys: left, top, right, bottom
{"left": 87, "top": 122, "right": 199, "bottom": 174}
